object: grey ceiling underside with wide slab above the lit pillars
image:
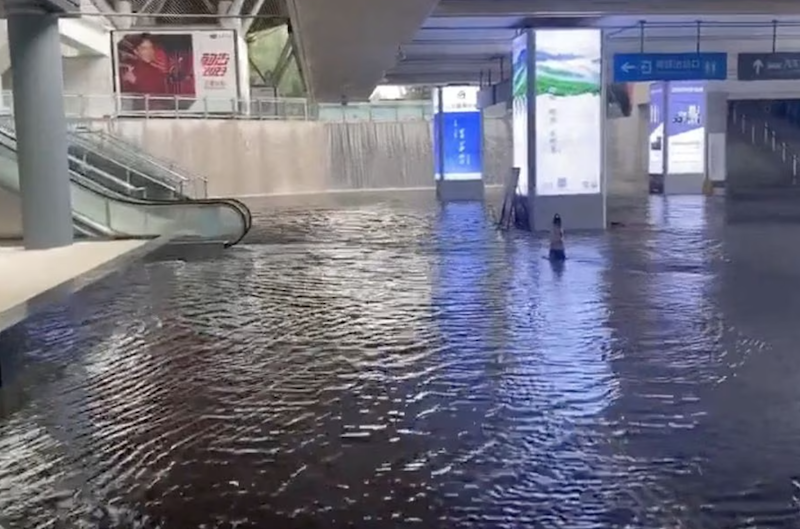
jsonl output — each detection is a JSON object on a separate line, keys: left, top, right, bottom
{"left": 288, "top": 0, "right": 800, "bottom": 101}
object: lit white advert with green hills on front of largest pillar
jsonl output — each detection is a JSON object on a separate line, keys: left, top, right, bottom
{"left": 535, "top": 29, "right": 606, "bottom": 196}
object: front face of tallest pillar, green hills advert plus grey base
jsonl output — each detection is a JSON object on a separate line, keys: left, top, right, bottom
{"left": 528, "top": 28, "right": 607, "bottom": 231}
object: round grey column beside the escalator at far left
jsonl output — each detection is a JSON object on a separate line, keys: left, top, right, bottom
{"left": 8, "top": 11, "right": 72, "bottom": 250}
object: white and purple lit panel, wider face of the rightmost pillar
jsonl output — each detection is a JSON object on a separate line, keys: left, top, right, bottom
{"left": 666, "top": 81, "right": 706, "bottom": 174}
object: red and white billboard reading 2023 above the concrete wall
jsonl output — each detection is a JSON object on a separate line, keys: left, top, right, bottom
{"left": 111, "top": 29, "right": 239, "bottom": 114}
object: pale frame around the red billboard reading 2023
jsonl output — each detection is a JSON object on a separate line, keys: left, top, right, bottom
{"left": 108, "top": 26, "right": 242, "bottom": 117}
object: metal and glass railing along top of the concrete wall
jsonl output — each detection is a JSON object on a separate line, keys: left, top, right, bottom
{"left": 0, "top": 91, "right": 433, "bottom": 123}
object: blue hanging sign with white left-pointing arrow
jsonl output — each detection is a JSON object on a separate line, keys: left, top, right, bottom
{"left": 614, "top": 52, "right": 728, "bottom": 83}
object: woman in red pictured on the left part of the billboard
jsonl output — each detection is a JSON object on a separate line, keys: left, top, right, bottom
{"left": 119, "top": 33, "right": 195, "bottom": 110}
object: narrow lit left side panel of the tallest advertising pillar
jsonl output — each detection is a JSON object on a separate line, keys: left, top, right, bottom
{"left": 511, "top": 34, "right": 528, "bottom": 196}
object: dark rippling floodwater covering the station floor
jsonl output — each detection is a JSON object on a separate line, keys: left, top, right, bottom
{"left": 0, "top": 191, "right": 800, "bottom": 529}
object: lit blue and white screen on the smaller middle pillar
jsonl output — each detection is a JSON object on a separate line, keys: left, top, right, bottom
{"left": 433, "top": 86, "right": 483, "bottom": 180}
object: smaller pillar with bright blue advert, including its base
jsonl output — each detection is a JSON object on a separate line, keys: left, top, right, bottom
{"left": 434, "top": 86, "right": 484, "bottom": 202}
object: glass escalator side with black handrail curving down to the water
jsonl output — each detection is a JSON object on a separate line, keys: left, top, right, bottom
{"left": 0, "top": 134, "right": 252, "bottom": 247}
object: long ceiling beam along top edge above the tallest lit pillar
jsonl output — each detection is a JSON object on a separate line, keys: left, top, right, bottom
{"left": 434, "top": 0, "right": 800, "bottom": 17}
